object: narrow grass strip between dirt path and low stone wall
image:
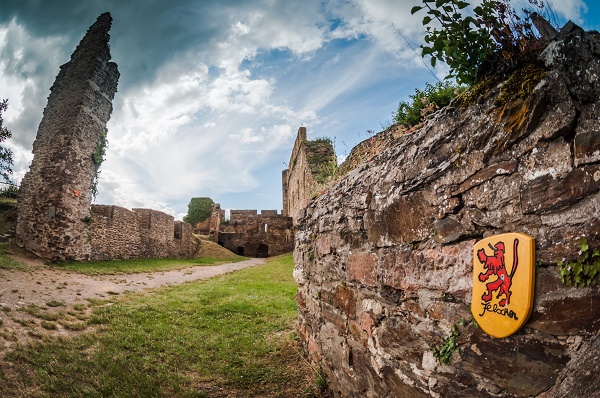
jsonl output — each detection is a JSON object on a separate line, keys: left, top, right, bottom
{"left": 56, "top": 256, "right": 248, "bottom": 275}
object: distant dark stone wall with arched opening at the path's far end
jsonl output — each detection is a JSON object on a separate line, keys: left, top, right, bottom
{"left": 218, "top": 210, "right": 294, "bottom": 257}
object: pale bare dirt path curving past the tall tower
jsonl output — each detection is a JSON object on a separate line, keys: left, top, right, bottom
{"left": 0, "top": 256, "right": 264, "bottom": 349}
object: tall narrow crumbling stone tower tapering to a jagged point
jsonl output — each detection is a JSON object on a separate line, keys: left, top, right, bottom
{"left": 16, "top": 13, "right": 119, "bottom": 261}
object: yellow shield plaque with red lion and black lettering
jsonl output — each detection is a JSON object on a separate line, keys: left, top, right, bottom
{"left": 471, "top": 233, "right": 535, "bottom": 338}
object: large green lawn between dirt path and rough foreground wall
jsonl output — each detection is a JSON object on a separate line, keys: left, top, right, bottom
{"left": 0, "top": 255, "right": 323, "bottom": 398}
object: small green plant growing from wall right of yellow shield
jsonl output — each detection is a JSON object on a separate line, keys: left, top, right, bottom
{"left": 557, "top": 238, "right": 600, "bottom": 287}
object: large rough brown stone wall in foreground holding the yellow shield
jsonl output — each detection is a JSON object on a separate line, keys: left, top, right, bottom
{"left": 294, "top": 25, "right": 600, "bottom": 398}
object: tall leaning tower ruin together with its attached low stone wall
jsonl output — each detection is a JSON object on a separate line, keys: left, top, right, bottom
{"left": 16, "top": 13, "right": 195, "bottom": 261}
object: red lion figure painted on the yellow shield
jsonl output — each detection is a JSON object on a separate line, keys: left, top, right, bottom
{"left": 477, "top": 239, "right": 519, "bottom": 307}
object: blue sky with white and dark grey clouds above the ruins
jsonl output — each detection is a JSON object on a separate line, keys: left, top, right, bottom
{"left": 0, "top": 0, "right": 600, "bottom": 217}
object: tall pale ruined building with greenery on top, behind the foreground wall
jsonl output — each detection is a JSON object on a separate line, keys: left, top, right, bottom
{"left": 281, "top": 127, "right": 337, "bottom": 223}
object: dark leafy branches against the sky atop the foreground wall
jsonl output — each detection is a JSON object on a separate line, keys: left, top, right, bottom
{"left": 411, "top": 0, "right": 544, "bottom": 85}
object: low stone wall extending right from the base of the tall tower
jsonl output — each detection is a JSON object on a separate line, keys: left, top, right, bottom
{"left": 88, "top": 205, "right": 196, "bottom": 260}
